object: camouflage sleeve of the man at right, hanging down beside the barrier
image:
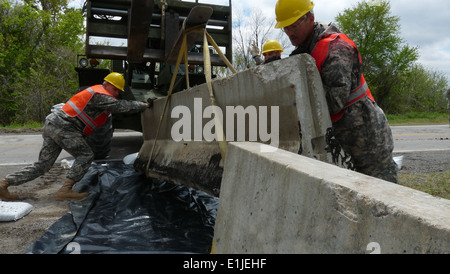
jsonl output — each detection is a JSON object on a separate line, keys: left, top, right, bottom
{"left": 321, "top": 39, "right": 359, "bottom": 114}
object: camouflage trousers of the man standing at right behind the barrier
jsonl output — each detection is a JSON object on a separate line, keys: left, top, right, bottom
{"left": 333, "top": 101, "right": 398, "bottom": 184}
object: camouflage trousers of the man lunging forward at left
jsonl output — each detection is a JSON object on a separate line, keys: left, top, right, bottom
{"left": 6, "top": 121, "right": 94, "bottom": 185}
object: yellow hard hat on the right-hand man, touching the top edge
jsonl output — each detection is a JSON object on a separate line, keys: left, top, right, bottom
{"left": 275, "top": 0, "right": 314, "bottom": 29}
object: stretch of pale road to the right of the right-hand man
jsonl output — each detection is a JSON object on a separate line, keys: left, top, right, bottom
{"left": 391, "top": 125, "right": 450, "bottom": 153}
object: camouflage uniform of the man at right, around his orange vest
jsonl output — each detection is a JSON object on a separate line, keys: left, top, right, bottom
{"left": 291, "top": 23, "right": 397, "bottom": 183}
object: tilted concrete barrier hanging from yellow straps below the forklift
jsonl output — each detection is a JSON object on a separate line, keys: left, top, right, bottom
{"left": 135, "top": 54, "right": 331, "bottom": 196}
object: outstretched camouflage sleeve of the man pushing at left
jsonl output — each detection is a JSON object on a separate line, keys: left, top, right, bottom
{"left": 92, "top": 94, "right": 147, "bottom": 113}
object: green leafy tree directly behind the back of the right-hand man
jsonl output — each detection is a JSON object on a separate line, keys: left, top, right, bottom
{"left": 336, "top": 0, "right": 419, "bottom": 110}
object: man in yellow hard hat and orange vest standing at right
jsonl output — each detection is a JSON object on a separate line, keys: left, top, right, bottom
{"left": 275, "top": 0, "right": 398, "bottom": 183}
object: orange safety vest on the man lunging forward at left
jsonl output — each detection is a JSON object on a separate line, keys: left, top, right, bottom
{"left": 62, "top": 85, "right": 114, "bottom": 136}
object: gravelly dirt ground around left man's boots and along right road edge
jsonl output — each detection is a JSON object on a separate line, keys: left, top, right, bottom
{"left": 0, "top": 130, "right": 450, "bottom": 254}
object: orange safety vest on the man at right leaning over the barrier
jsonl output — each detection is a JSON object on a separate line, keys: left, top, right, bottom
{"left": 311, "top": 33, "right": 375, "bottom": 123}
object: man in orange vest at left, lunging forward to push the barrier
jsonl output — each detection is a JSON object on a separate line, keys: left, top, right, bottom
{"left": 0, "top": 72, "right": 150, "bottom": 201}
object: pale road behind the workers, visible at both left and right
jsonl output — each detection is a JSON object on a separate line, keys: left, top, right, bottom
{"left": 0, "top": 125, "right": 450, "bottom": 166}
